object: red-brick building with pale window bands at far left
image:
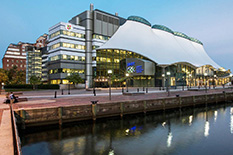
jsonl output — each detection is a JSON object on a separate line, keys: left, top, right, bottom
{"left": 2, "top": 42, "right": 32, "bottom": 70}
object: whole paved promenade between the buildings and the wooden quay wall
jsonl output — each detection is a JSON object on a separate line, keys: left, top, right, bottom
{"left": 10, "top": 87, "right": 232, "bottom": 109}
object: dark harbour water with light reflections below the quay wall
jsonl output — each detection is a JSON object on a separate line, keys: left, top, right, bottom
{"left": 20, "top": 103, "right": 233, "bottom": 155}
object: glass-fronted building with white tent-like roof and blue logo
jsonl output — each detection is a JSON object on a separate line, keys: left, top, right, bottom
{"left": 94, "top": 16, "right": 231, "bottom": 86}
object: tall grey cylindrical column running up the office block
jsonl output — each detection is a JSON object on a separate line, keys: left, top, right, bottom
{"left": 85, "top": 9, "right": 93, "bottom": 88}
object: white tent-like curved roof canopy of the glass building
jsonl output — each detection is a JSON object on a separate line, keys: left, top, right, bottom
{"left": 98, "top": 20, "right": 220, "bottom": 69}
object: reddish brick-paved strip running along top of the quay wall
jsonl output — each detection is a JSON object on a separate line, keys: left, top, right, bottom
{"left": 10, "top": 89, "right": 232, "bottom": 109}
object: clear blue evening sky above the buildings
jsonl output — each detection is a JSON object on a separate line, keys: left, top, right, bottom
{"left": 0, "top": 0, "right": 233, "bottom": 71}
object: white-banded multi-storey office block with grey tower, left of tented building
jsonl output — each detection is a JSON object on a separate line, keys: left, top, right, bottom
{"left": 47, "top": 5, "right": 125, "bottom": 87}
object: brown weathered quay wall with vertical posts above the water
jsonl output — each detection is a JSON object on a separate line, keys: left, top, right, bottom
{"left": 15, "top": 92, "right": 233, "bottom": 127}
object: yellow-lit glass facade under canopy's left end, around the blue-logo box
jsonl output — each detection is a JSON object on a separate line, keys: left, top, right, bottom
{"left": 93, "top": 49, "right": 154, "bottom": 87}
